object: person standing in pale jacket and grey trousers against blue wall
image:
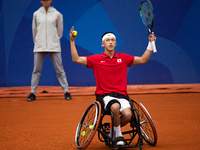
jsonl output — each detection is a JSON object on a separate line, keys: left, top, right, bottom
{"left": 27, "top": 0, "right": 71, "bottom": 102}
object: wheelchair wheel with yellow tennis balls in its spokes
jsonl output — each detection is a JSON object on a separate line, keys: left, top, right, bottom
{"left": 75, "top": 102, "right": 101, "bottom": 150}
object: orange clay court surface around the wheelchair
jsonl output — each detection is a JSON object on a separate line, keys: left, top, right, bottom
{"left": 0, "top": 85, "right": 200, "bottom": 150}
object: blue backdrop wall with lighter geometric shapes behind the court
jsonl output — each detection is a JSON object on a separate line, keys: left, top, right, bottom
{"left": 0, "top": 0, "right": 200, "bottom": 87}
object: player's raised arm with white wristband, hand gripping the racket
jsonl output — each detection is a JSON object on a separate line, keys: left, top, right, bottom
{"left": 133, "top": 33, "right": 156, "bottom": 65}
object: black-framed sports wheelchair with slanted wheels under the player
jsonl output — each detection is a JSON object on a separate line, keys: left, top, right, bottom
{"left": 75, "top": 94, "right": 157, "bottom": 150}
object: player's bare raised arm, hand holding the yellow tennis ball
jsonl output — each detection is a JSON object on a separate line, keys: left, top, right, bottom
{"left": 69, "top": 27, "right": 87, "bottom": 65}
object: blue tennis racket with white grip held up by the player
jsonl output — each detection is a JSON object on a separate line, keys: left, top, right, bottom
{"left": 140, "top": 0, "right": 157, "bottom": 53}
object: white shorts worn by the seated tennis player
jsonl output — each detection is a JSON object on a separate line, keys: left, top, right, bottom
{"left": 103, "top": 96, "right": 131, "bottom": 112}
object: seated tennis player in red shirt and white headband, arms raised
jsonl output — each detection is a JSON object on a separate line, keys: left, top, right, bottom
{"left": 70, "top": 27, "right": 156, "bottom": 145}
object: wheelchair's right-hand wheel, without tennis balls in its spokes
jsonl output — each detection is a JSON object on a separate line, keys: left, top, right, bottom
{"left": 131, "top": 100, "right": 157, "bottom": 146}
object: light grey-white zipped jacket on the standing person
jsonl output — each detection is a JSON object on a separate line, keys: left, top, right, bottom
{"left": 32, "top": 6, "right": 63, "bottom": 52}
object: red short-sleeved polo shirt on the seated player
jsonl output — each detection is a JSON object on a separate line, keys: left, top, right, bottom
{"left": 86, "top": 53, "right": 134, "bottom": 96}
